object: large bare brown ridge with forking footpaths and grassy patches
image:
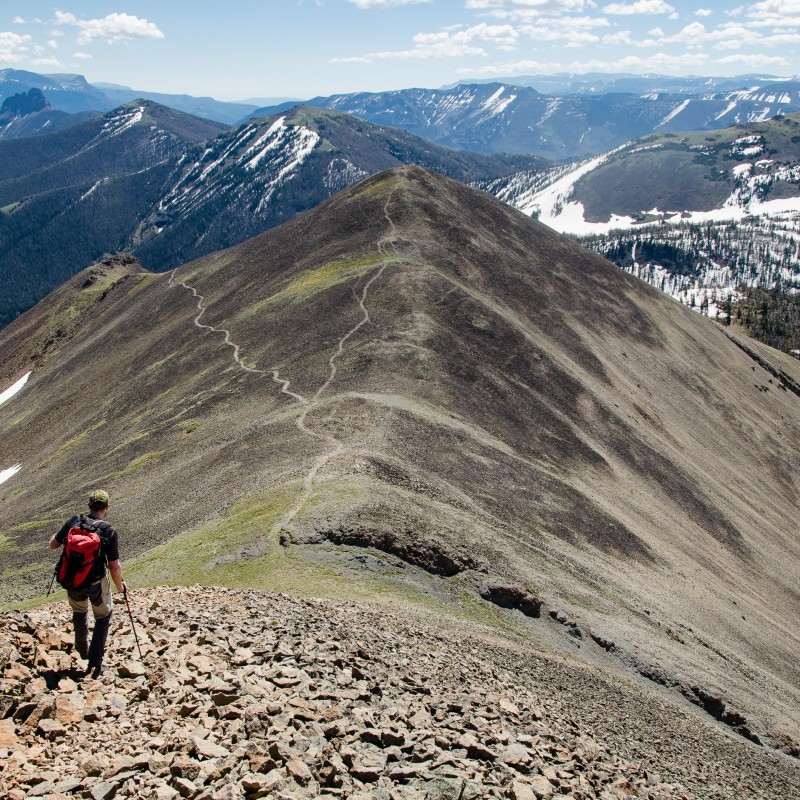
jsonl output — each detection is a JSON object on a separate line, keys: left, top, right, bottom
{"left": 0, "top": 167, "right": 800, "bottom": 751}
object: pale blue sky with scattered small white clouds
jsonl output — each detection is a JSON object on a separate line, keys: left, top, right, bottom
{"left": 0, "top": 0, "right": 800, "bottom": 100}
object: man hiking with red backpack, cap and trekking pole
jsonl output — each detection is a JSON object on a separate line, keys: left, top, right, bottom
{"left": 50, "top": 489, "right": 127, "bottom": 678}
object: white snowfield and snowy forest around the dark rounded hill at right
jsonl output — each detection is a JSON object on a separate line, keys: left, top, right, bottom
{"left": 486, "top": 141, "right": 800, "bottom": 317}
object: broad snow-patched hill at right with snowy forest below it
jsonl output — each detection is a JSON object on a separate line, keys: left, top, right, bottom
{"left": 483, "top": 109, "right": 800, "bottom": 328}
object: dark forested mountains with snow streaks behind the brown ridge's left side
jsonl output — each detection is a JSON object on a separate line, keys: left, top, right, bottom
{"left": 0, "top": 101, "right": 547, "bottom": 324}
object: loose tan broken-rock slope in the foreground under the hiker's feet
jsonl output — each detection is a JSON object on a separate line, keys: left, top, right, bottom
{"left": 0, "top": 587, "right": 800, "bottom": 800}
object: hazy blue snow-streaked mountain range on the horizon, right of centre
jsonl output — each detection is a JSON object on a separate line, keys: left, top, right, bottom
{"left": 253, "top": 81, "right": 800, "bottom": 161}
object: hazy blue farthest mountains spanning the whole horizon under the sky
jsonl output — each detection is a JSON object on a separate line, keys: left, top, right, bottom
{"left": 6, "top": 69, "right": 800, "bottom": 161}
